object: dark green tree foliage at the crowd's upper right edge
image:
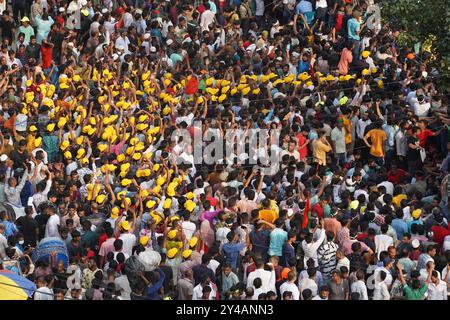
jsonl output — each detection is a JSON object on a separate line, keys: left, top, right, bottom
{"left": 380, "top": 0, "right": 450, "bottom": 89}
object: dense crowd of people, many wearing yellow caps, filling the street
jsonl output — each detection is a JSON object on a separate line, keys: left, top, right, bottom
{"left": 0, "top": 0, "right": 450, "bottom": 300}
